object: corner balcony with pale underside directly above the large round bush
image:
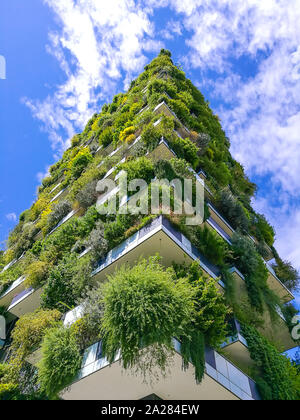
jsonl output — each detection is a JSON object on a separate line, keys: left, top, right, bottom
{"left": 92, "top": 216, "right": 224, "bottom": 287}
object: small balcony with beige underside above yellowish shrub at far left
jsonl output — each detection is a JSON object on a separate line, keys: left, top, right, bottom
{"left": 7, "top": 288, "right": 42, "bottom": 318}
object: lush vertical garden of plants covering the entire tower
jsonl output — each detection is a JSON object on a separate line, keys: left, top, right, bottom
{"left": 0, "top": 50, "right": 300, "bottom": 400}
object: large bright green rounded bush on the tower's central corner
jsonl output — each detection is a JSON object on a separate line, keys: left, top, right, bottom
{"left": 102, "top": 257, "right": 194, "bottom": 370}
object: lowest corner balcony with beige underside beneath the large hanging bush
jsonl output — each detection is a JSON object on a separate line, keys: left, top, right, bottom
{"left": 62, "top": 339, "right": 260, "bottom": 401}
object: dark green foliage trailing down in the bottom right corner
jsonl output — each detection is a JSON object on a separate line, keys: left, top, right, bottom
{"left": 243, "top": 326, "right": 300, "bottom": 401}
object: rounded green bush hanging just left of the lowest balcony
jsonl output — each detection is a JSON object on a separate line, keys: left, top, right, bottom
{"left": 38, "top": 326, "right": 82, "bottom": 399}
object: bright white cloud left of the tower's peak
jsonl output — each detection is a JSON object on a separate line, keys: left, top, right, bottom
{"left": 24, "top": 0, "right": 162, "bottom": 152}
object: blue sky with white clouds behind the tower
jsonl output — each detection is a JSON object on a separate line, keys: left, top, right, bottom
{"left": 0, "top": 0, "right": 300, "bottom": 320}
